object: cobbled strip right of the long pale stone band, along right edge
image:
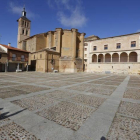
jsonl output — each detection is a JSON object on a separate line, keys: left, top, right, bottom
{"left": 107, "top": 76, "right": 140, "bottom": 140}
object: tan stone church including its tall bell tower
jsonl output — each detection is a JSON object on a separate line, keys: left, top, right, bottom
{"left": 18, "top": 8, "right": 85, "bottom": 72}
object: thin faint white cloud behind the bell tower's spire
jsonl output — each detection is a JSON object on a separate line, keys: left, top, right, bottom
{"left": 9, "top": 2, "right": 38, "bottom": 18}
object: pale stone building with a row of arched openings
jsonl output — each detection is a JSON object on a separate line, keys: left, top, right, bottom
{"left": 84, "top": 32, "right": 140, "bottom": 74}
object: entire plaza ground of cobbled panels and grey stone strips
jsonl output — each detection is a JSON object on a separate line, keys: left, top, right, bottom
{"left": 0, "top": 72, "right": 140, "bottom": 140}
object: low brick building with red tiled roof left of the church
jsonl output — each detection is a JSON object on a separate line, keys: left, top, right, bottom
{"left": 0, "top": 44, "right": 29, "bottom": 72}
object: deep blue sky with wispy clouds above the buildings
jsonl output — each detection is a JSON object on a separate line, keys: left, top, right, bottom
{"left": 0, "top": 0, "right": 140, "bottom": 47}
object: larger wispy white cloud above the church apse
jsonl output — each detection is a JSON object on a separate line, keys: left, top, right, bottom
{"left": 48, "top": 0, "right": 87, "bottom": 28}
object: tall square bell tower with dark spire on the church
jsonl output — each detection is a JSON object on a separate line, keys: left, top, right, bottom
{"left": 17, "top": 7, "right": 31, "bottom": 50}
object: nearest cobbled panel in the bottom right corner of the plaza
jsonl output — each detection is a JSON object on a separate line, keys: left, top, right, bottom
{"left": 107, "top": 116, "right": 140, "bottom": 140}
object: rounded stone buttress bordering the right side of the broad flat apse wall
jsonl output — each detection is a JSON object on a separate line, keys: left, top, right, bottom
{"left": 72, "top": 29, "right": 78, "bottom": 58}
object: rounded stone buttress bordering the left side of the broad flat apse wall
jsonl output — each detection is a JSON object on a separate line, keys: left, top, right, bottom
{"left": 56, "top": 28, "right": 62, "bottom": 52}
